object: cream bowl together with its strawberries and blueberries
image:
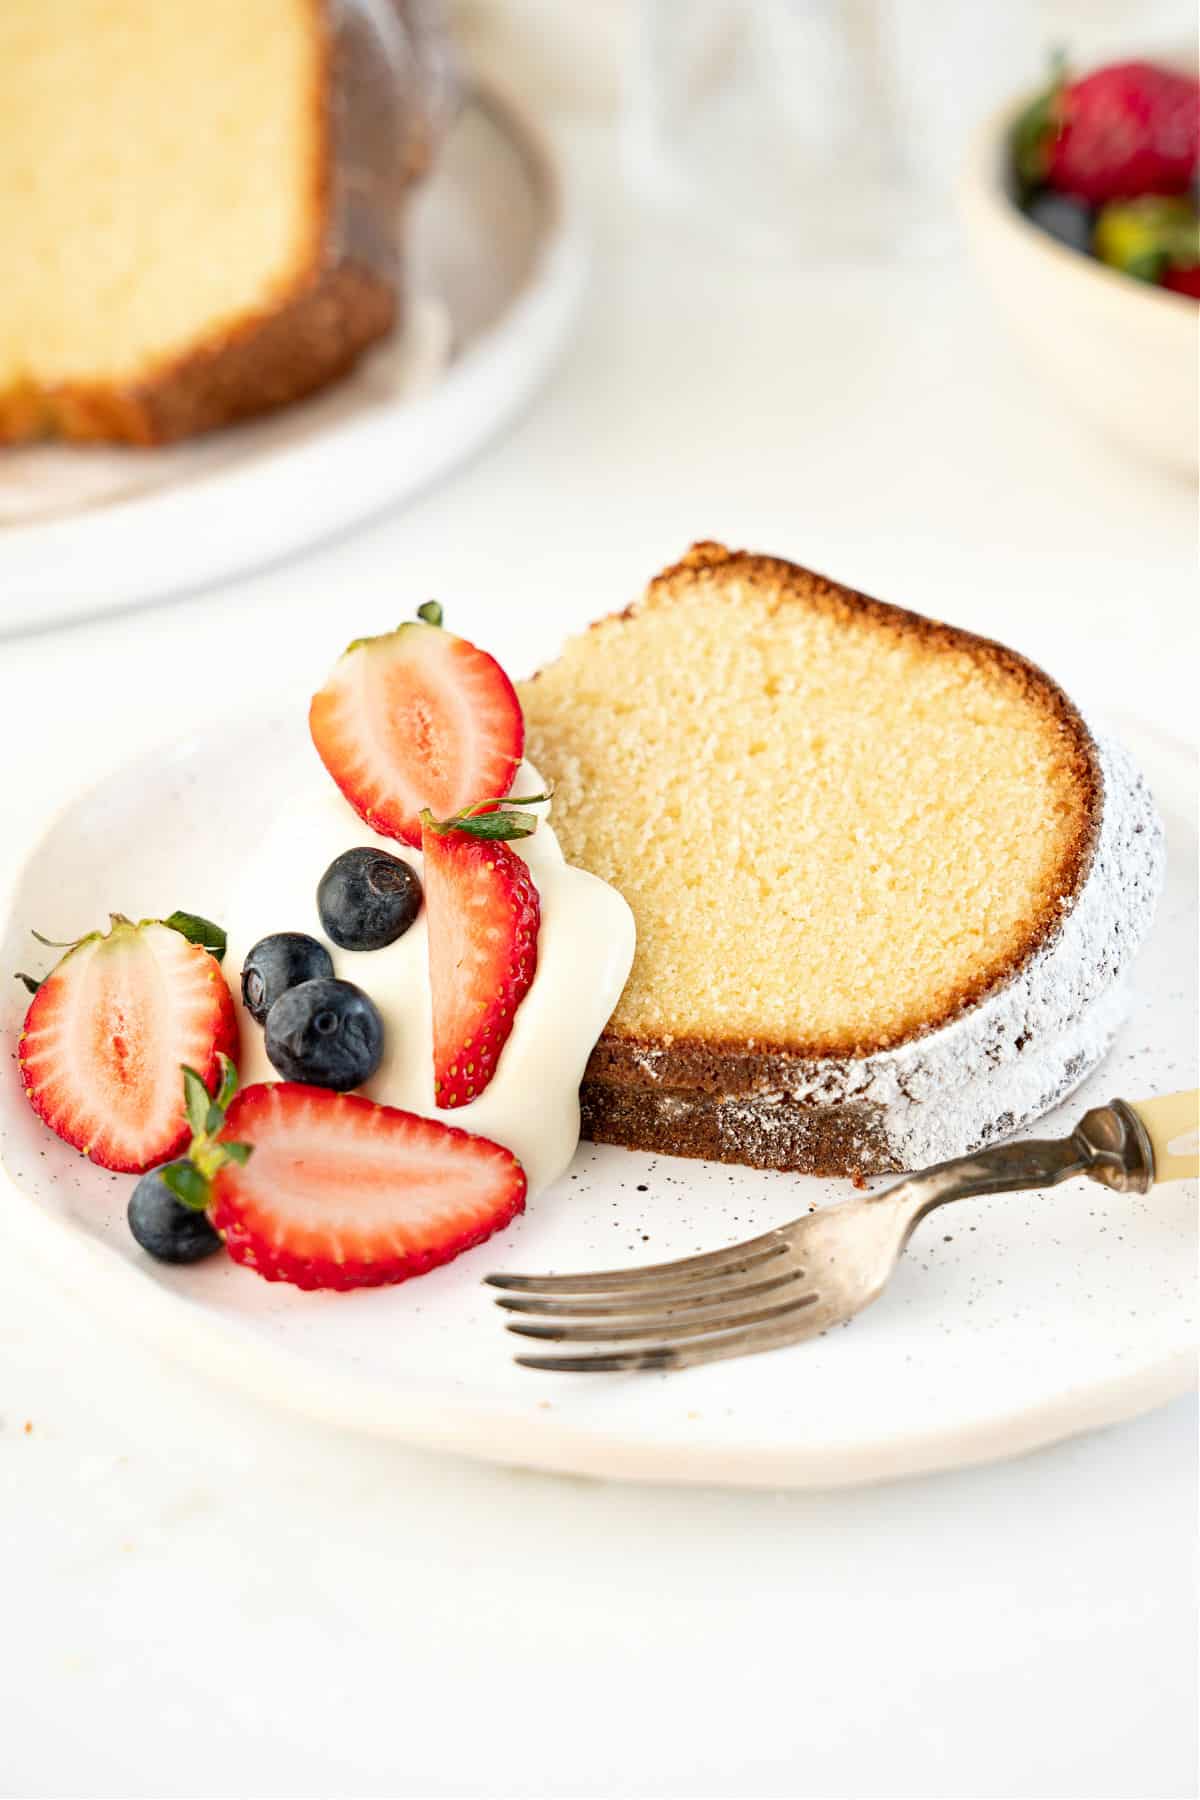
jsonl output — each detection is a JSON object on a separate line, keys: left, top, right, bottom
{"left": 957, "top": 59, "right": 1200, "bottom": 477}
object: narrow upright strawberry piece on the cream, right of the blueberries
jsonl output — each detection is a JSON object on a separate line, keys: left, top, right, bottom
{"left": 421, "top": 814, "right": 542, "bottom": 1109}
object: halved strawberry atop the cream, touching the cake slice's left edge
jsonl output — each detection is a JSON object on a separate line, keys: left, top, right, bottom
{"left": 308, "top": 603, "right": 525, "bottom": 846}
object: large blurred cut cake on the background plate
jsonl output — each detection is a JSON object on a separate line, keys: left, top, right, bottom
{"left": 0, "top": 0, "right": 446, "bottom": 445}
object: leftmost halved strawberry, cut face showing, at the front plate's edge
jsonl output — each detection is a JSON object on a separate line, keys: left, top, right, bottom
{"left": 20, "top": 914, "right": 237, "bottom": 1174}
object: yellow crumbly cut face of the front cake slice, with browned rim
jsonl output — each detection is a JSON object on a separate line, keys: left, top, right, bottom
{"left": 520, "top": 545, "right": 1101, "bottom": 1057}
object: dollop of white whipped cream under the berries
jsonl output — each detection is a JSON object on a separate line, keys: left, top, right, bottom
{"left": 223, "top": 763, "right": 635, "bottom": 1195}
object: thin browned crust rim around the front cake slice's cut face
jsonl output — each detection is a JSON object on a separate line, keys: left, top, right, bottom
{"left": 521, "top": 542, "right": 1103, "bottom": 1087}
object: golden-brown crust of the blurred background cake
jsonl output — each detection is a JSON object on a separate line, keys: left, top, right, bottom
{"left": 0, "top": 0, "right": 406, "bottom": 446}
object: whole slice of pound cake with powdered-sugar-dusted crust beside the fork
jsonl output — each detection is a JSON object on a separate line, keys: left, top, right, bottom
{"left": 520, "top": 544, "right": 1162, "bottom": 1175}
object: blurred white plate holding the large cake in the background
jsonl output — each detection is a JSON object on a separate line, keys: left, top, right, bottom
{"left": 0, "top": 88, "right": 587, "bottom": 634}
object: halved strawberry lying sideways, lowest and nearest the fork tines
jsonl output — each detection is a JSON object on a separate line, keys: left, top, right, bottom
{"left": 210, "top": 1082, "right": 525, "bottom": 1289}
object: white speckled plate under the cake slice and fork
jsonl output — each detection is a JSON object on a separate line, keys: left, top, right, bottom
{"left": 0, "top": 707, "right": 1196, "bottom": 1487}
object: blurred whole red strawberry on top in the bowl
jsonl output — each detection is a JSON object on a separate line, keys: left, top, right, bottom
{"left": 1047, "top": 63, "right": 1200, "bottom": 205}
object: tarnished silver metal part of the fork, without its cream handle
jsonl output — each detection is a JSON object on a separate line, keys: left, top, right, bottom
{"left": 484, "top": 1100, "right": 1155, "bottom": 1373}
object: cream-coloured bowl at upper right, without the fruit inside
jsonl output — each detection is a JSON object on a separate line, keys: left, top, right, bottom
{"left": 959, "top": 97, "right": 1200, "bottom": 473}
